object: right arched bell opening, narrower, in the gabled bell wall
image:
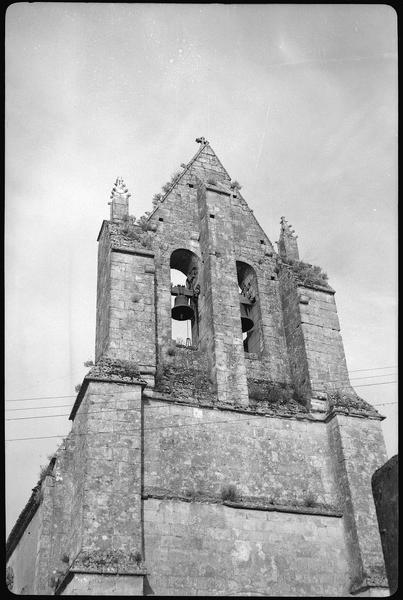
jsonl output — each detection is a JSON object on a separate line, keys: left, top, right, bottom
{"left": 236, "top": 261, "right": 263, "bottom": 354}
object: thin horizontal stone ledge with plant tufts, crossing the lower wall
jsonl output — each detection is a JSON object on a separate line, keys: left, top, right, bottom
{"left": 142, "top": 488, "right": 343, "bottom": 518}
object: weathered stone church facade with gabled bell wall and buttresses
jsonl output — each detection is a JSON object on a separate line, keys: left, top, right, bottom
{"left": 7, "top": 138, "right": 388, "bottom": 596}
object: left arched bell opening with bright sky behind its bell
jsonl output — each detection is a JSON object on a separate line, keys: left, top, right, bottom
{"left": 170, "top": 248, "right": 199, "bottom": 346}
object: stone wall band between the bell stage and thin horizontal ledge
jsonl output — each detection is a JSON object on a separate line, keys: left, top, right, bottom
{"left": 144, "top": 400, "right": 338, "bottom": 507}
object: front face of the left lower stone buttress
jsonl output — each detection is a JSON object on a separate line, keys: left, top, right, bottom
{"left": 69, "top": 381, "right": 141, "bottom": 552}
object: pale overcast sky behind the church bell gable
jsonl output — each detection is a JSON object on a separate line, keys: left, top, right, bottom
{"left": 5, "top": 2, "right": 397, "bottom": 527}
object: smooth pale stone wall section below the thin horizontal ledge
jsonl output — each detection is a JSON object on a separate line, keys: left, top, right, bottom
{"left": 144, "top": 499, "right": 348, "bottom": 596}
